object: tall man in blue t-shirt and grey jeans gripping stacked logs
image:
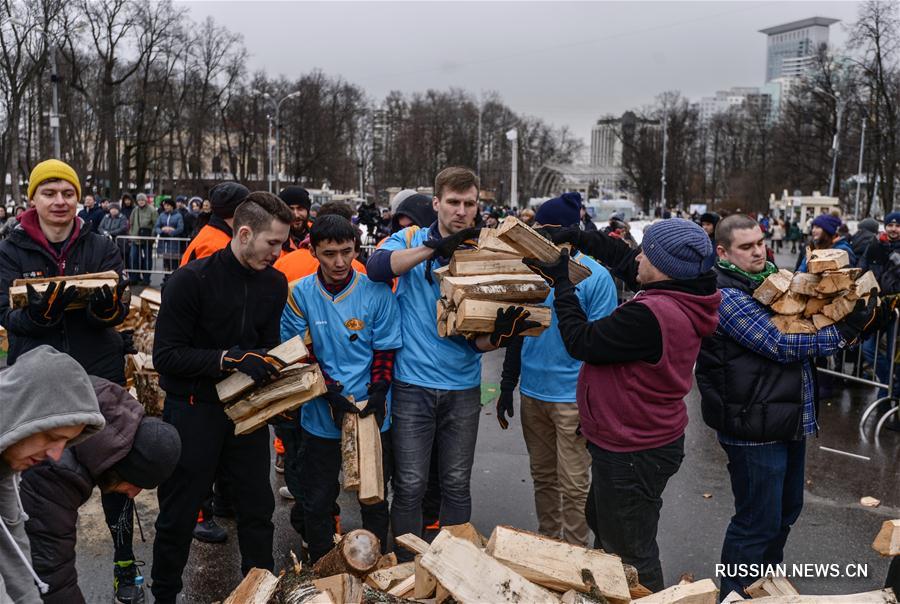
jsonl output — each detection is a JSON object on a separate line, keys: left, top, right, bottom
{"left": 366, "top": 167, "right": 536, "bottom": 559}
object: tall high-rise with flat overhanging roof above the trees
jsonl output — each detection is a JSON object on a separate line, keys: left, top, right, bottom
{"left": 759, "top": 17, "right": 839, "bottom": 82}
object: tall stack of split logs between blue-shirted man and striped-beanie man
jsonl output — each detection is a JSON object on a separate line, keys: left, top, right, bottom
{"left": 434, "top": 216, "right": 591, "bottom": 337}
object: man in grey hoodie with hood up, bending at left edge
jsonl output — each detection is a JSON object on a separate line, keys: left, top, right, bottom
{"left": 0, "top": 346, "right": 105, "bottom": 604}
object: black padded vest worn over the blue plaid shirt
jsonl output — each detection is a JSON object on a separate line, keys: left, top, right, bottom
{"left": 696, "top": 266, "right": 818, "bottom": 442}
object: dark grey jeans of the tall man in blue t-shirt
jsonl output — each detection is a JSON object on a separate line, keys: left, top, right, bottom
{"left": 391, "top": 380, "right": 481, "bottom": 560}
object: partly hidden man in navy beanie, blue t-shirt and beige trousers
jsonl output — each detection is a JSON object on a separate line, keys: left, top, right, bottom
{"left": 497, "top": 193, "right": 617, "bottom": 547}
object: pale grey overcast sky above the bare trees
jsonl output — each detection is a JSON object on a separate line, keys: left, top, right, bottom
{"left": 183, "top": 0, "right": 857, "bottom": 144}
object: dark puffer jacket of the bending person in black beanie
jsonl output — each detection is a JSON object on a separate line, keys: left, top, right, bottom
{"left": 20, "top": 377, "right": 144, "bottom": 604}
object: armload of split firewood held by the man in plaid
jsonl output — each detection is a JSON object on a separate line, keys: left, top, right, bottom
{"left": 753, "top": 249, "right": 880, "bottom": 334}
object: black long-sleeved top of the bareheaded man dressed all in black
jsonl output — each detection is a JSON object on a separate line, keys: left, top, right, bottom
{"left": 153, "top": 245, "right": 287, "bottom": 403}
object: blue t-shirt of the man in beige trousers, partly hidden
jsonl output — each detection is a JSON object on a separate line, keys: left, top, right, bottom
{"left": 519, "top": 254, "right": 618, "bottom": 403}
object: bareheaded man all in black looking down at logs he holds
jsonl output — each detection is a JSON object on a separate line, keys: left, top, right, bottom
{"left": 152, "top": 191, "right": 292, "bottom": 604}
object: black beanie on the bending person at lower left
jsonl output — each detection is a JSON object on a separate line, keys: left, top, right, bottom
{"left": 112, "top": 420, "right": 181, "bottom": 489}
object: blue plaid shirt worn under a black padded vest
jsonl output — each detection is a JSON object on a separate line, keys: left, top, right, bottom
{"left": 716, "top": 288, "right": 845, "bottom": 445}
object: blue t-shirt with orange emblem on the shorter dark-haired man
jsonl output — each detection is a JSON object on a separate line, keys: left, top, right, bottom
{"left": 281, "top": 271, "right": 403, "bottom": 439}
